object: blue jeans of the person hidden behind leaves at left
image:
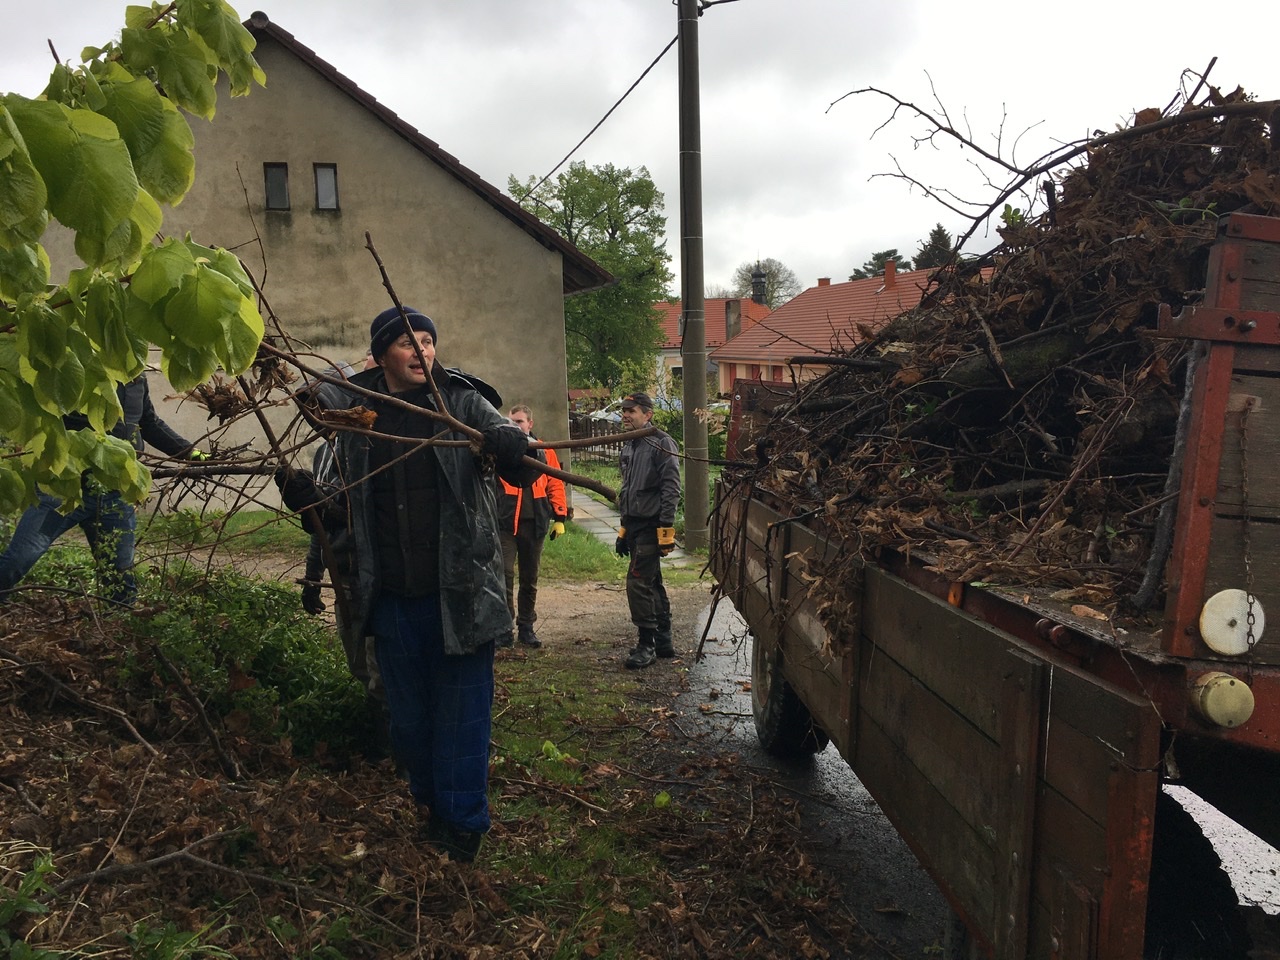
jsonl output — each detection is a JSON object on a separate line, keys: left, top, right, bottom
{"left": 0, "top": 488, "right": 138, "bottom": 604}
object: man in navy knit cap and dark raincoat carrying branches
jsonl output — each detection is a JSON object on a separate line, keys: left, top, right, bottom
{"left": 299, "top": 307, "right": 529, "bottom": 861}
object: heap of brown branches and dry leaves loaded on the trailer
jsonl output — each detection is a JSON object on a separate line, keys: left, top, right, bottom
{"left": 742, "top": 82, "right": 1280, "bottom": 624}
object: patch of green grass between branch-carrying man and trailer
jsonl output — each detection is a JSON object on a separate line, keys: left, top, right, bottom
{"left": 486, "top": 640, "right": 664, "bottom": 960}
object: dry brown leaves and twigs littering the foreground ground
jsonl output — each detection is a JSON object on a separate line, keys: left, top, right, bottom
{"left": 0, "top": 600, "right": 865, "bottom": 960}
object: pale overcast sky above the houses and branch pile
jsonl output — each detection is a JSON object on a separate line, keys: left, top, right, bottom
{"left": 0, "top": 0, "right": 1280, "bottom": 294}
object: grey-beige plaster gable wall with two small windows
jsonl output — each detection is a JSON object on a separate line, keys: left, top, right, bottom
{"left": 176, "top": 38, "right": 568, "bottom": 438}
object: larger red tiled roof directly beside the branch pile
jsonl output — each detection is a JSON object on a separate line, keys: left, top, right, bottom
{"left": 710, "top": 269, "right": 934, "bottom": 364}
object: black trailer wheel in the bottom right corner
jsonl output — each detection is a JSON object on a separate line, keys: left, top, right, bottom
{"left": 1142, "top": 790, "right": 1251, "bottom": 960}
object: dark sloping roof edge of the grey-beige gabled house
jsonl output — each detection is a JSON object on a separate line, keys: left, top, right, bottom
{"left": 244, "top": 12, "right": 617, "bottom": 296}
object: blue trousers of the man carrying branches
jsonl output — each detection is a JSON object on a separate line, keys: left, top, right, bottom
{"left": 372, "top": 593, "right": 493, "bottom": 833}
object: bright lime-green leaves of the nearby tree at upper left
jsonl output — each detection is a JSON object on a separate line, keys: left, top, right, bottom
{"left": 0, "top": 0, "right": 265, "bottom": 513}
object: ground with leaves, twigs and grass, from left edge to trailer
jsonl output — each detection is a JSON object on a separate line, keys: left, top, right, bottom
{"left": 0, "top": 585, "right": 911, "bottom": 959}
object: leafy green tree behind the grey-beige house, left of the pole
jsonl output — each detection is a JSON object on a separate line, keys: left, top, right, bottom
{"left": 507, "top": 163, "right": 673, "bottom": 390}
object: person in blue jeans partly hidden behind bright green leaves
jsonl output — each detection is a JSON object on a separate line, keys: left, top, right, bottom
{"left": 0, "top": 374, "right": 205, "bottom": 605}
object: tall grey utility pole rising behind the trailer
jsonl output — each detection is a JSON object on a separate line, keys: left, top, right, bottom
{"left": 676, "top": 0, "right": 710, "bottom": 550}
